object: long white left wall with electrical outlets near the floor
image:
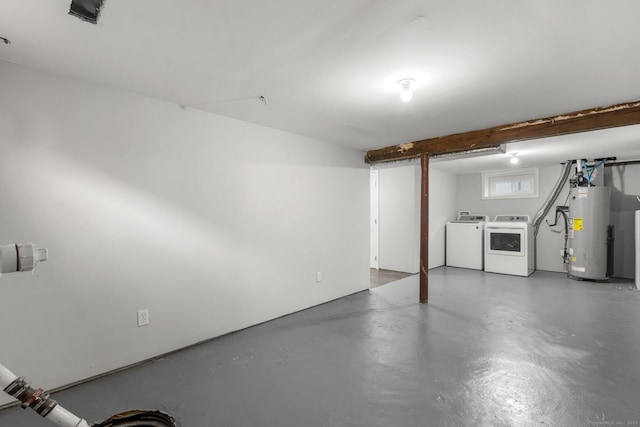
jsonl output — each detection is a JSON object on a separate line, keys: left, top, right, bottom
{"left": 0, "top": 62, "right": 369, "bottom": 404}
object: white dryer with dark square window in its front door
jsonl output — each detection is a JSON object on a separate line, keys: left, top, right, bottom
{"left": 484, "top": 215, "right": 534, "bottom": 276}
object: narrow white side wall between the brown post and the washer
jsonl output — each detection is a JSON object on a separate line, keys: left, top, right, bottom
{"left": 429, "top": 167, "right": 458, "bottom": 268}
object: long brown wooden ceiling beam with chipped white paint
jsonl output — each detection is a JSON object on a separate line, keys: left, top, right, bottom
{"left": 365, "top": 101, "right": 640, "bottom": 163}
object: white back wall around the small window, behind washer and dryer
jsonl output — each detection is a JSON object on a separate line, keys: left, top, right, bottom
{"left": 457, "top": 165, "right": 569, "bottom": 272}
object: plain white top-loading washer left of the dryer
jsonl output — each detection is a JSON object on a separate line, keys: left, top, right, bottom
{"left": 446, "top": 214, "right": 489, "bottom": 270}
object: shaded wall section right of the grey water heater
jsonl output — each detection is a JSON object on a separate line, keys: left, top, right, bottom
{"left": 604, "top": 165, "right": 640, "bottom": 279}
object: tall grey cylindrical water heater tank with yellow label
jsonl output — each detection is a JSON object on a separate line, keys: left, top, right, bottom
{"left": 569, "top": 187, "right": 611, "bottom": 280}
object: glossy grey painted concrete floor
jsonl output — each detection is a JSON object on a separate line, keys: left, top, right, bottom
{"left": 0, "top": 267, "right": 640, "bottom": 427}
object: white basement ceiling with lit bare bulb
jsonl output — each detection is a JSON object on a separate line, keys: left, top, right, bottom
{"left": 0, "top": 0, "right": 640, "bottom": 170}
